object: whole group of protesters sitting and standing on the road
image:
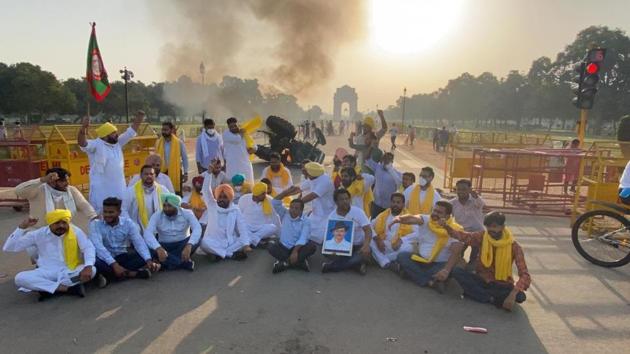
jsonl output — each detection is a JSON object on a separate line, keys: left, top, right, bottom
{"left": 3, "top": 111, "right": 531, "bottom": 310}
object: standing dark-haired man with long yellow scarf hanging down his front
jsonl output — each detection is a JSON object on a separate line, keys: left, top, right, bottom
{"left": 155, "top": 122, "right": 188, "bottom": 194}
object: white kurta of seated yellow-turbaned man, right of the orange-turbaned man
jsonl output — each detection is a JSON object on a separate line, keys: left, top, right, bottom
{"left": 238, "top": 193, "right": 280, "bottom": 246}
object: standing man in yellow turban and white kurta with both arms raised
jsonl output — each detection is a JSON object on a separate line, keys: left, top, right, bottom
{"left": 77, "top": 111, "right": 145, "bottom": 214}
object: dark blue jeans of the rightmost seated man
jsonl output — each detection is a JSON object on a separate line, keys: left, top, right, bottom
{"left": 451, "top": 268, "right": 527, "bottom": 306}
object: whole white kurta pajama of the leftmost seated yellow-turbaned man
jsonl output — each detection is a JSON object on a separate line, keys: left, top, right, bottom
{"left": 2, "top": 225, "right": 96, "bottom": 294}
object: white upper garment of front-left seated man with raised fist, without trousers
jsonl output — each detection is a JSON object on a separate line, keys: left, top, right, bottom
{"left": 2, "top": 225, "right": 96, "bottom": 269}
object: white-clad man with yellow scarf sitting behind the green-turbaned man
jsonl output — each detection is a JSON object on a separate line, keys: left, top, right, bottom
{"left": 122, "top": 165, "right": 169, "bottom": 232}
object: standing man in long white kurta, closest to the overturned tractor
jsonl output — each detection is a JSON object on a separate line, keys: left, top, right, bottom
{"left": 223, "top": 118, "right": 256, "bottom": 185}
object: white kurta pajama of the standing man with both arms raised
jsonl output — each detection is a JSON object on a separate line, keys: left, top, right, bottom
{"left": 81, "top": 127, "right": 136, "bottom": 214}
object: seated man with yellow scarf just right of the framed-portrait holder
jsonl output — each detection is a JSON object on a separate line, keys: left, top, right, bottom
{"left": 370, "top": 193, "right": 418, "bottom": 268}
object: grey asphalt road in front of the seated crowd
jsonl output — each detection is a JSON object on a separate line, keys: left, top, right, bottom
{"left": 0, "top": 135, "right": 630, "bottom": 353}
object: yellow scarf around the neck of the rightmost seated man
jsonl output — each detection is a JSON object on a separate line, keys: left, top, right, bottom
{"left": 480, "top": 227, "right": 514, "bottom": 280}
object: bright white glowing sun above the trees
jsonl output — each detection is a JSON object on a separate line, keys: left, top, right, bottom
{"left": 370, "top": 0, "right": 464, "bottom": 54}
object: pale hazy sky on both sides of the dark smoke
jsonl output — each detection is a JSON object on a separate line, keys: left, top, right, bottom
{"left": 0, "top": 0, "right": 630, "bottom": 112}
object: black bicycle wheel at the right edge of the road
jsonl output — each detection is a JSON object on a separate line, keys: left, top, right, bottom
{"left": 571, "top": 210, "right": 630, "bottom": 267}
